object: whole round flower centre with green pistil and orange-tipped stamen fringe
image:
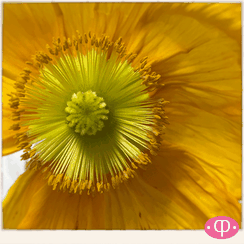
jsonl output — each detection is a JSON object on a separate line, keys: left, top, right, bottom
{"left": 10, "top": 33, "right": 167, "bottom": 194}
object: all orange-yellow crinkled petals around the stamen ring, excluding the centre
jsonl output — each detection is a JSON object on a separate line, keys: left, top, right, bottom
{"left": 3, "top": 3, "right": 241, "bottom": 229}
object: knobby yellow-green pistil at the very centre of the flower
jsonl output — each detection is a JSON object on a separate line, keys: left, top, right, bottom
{"left": 65, "top": 91, "right": 109, "bottom": 136}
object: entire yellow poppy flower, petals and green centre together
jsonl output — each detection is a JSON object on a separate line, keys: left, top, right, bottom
{"left": 3, "top": 3, "right": 241, "bottom": 229}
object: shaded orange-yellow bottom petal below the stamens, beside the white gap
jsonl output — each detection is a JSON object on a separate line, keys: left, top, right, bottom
{"left": 3, "top": 151, "right": 240, "bottom": 229}
